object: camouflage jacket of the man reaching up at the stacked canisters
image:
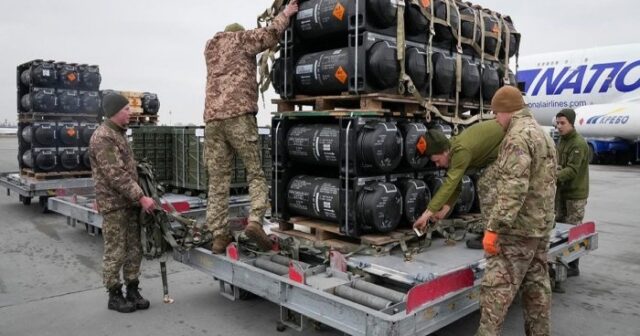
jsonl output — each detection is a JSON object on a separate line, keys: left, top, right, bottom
{"left": 204, "top": 13, "right": 289, "bottom": 123}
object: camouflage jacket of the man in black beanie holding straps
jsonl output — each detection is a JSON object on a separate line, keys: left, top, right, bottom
{"left": 89, "top": 120, "right": 144, "bottom": 214}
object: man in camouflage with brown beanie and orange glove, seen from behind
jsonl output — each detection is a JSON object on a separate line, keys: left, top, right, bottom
{"left": 476, "top": 86, "right": 556, "bottom": 336}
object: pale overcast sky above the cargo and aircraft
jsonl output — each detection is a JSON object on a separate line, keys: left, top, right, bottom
{"left": 0, "top": 0, "right": 640, "bottom": 125}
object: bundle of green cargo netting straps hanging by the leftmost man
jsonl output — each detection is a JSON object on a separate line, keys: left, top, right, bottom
{"left": 137, "top": 161, "right": 211, "bottom": 303}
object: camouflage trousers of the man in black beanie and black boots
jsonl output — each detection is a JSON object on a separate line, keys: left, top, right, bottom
{"left": 102, "top": 208, "right": 142, "bottom": 289}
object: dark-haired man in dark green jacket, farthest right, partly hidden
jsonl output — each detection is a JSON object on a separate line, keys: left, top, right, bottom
{"left": 554, "top": 109, "right": 589, "bottom": 293}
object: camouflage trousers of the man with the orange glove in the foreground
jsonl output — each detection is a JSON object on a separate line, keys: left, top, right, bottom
{"left": 476, "top": 234, "right": 551, "bottom": 336}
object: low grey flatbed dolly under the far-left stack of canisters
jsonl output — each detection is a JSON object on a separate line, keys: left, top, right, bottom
{"left": 0, "top": 172, "right": 94, "bottom": 212}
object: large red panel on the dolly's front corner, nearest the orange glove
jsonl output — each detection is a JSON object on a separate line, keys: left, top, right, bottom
{"left": 407, "top": 268, "right": 474, "bottom": 314}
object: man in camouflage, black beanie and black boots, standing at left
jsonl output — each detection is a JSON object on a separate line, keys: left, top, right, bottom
{"left": 89, "top": 93, "right": 155, "bottom": 313}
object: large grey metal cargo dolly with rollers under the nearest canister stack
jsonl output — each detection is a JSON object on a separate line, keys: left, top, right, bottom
{"left": 173, "top": 223, "right": 598, "bottom": 336}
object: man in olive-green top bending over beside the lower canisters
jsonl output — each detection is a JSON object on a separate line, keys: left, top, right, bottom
{"left": 413, "top": 120, "right": 505, "bottom": 249}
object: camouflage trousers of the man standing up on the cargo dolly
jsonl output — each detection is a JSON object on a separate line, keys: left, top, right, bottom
{"left": 204, "top": 114, "right": 270, "bottom": 237}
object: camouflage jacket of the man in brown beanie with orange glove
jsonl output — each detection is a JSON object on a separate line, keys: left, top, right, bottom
{"left": 487, "top": 108, "right": 556, "bottom": 237}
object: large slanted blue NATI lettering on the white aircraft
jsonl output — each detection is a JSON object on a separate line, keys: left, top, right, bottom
{"left": 517, "top": 60, "right": 640, "bottom": 96}
